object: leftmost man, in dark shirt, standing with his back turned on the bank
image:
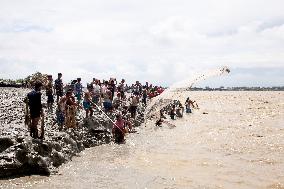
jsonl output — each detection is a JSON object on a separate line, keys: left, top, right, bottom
{"left": 27, "top": 82, "right": 44, "bottom": 139}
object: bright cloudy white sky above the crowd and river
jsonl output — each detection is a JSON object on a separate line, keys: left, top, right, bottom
{"left": 0, "top": 0, "right": 284, "bottom": 87}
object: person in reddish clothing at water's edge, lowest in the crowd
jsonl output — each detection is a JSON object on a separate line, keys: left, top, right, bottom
{"left": 112, "top": 114, "right": 125, "bottom": 143}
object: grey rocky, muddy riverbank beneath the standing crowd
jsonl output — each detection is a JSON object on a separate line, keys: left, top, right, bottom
{"left": 0, "top": 88, "right": 143, "bottom": 178}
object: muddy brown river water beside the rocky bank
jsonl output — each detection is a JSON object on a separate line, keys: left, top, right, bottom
{"left": 0, "top": 92, "right": 284, "bottom": 189}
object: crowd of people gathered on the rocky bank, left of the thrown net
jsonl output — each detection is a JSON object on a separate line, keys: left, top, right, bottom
{"left": 25, "top": 73, "right": 164, "bottom": 142}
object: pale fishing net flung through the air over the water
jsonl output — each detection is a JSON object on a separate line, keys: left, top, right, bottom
{"left": 145, "top": 66, "right": 230, "bottom": 120}
